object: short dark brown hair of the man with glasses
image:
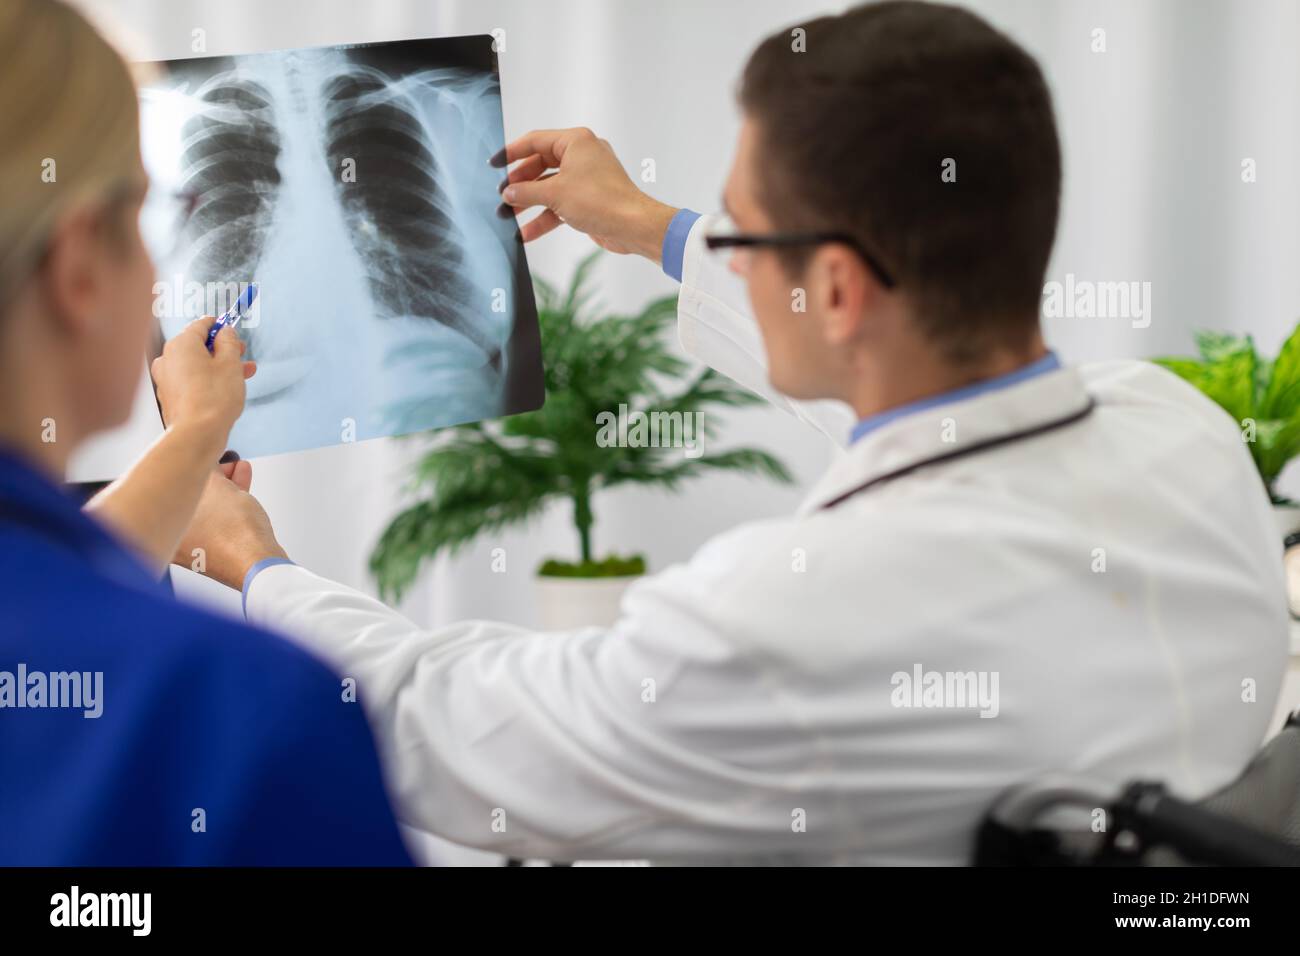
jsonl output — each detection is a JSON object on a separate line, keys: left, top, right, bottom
{"left": 740, "top": 1, "right": 1061, "bottom": 360}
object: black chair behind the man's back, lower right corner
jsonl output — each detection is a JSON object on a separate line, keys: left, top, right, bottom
{"left": 974, "top": 710, "right": 1300, "bottom": 866}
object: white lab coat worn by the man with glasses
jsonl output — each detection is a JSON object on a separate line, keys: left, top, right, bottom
{"left": 247, "top": 219, "right": 1287, "bottom": 864}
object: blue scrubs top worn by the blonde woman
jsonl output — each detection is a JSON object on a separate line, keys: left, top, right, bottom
{"left": 0, "top": 451, "right": 410, "bottom": 866}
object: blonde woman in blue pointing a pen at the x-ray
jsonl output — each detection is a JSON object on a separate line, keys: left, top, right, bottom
{"left": 0, "top": 0, "right": 408, "bottom": 865}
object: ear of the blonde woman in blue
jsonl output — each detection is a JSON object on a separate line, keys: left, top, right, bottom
{"left": 40, "top": 209, "right": 105, "bottom": 336}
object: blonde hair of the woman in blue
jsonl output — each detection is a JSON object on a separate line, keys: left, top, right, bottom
{"left": 0, "top": 0, "right": 140, "bottom": 308}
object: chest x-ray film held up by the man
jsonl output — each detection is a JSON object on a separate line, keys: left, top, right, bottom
{"left": 140, "top": 36, "right": 543, "bottom": 457}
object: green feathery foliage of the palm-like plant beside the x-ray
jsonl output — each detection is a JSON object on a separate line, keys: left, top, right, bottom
{"left": 371, "top": 252, "right": 790, "bottom": 597}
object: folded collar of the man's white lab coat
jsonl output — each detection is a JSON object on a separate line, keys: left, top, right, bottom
{"left": 800, "top": 368, "right": 1092, "bottom": 514}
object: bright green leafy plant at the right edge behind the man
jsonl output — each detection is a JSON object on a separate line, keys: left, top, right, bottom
{"left": 1154, "top": 325, "right": 1300, "bottom": 537}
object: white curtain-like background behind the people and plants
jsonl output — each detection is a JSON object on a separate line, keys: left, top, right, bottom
{"left": 83, "top": 0, "right": 1300, "bottom": 624}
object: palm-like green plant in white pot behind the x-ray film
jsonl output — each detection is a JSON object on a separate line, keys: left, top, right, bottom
{"left": 371, "top": 252, "right": 790, "bottom": 630}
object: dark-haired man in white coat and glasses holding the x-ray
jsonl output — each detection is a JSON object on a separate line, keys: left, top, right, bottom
{"left": 182, "top": 3, "right": 1287, "bottom": 864}
